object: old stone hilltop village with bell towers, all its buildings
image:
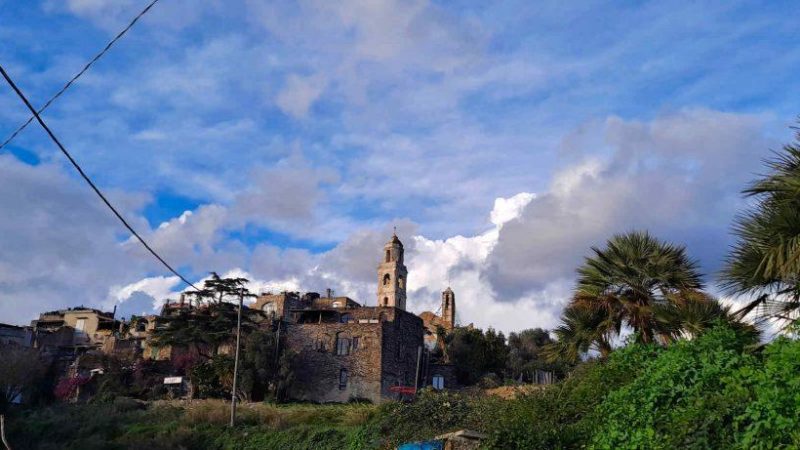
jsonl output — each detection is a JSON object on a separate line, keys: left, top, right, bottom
{"left": 0, "top": 235, "right": 457, "bottom": 402}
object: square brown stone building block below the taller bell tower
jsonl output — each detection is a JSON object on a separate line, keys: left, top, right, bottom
{"left": 285, "top": 307, "right": 423, "bottom": 402}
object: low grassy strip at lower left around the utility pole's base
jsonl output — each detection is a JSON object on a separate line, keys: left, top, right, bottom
{"left": 8, "top": 399, "right": 377, "bottom": 450}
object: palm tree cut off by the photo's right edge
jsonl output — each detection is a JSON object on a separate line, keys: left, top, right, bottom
{"left": 721, "top": 133, "right": 800, "bottom": 326}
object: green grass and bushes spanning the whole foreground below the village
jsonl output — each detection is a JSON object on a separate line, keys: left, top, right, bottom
{"left": 10, "top": 325, "right": 800, "bottom": 450}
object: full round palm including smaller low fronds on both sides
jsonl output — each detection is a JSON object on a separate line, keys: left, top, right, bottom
{"left": 547, "top": 232, "right": 755, "bottom": 363}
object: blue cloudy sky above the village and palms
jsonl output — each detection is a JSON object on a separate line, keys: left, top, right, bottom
{"left": 0, "top": 0, "right": 800, "bottom": 332}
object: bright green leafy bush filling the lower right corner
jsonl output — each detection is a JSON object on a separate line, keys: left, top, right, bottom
{"left": 591, "top": 326, "right": 800, "bottom": 449}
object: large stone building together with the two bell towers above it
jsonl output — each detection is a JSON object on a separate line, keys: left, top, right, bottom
{"left": 252, "top": 235, "right": 455, "bottom": 402}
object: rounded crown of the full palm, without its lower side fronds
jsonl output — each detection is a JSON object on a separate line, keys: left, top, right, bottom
{"left": 572, "top": 232, "right": 703, "bottom": 343}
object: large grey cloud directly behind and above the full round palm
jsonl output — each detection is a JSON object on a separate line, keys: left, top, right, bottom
{"left": 487, "top": 109, "right": 774, "bottom": 301}
